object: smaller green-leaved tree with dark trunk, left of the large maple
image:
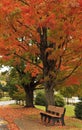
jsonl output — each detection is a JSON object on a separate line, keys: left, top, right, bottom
{"left": 7, "top": 59, "right": 39, "bottom": 107}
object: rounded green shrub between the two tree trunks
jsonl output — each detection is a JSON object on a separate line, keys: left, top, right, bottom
{"left": 35, "top": 92, "right": 47, "bottom": 106}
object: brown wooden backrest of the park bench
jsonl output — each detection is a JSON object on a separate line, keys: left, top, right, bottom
{"left": 47, "top": 105, "right": 66, "bottom": 116}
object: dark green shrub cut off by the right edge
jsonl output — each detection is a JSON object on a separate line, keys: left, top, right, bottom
{"left": 75, "top": 101, "right": 82, "bottom": 119}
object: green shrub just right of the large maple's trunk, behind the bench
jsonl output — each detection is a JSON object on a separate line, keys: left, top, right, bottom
{"left": 55, "top": 94, "right": 65, "bottom": 107}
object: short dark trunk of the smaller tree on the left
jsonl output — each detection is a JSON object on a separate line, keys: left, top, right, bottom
{"left": 24, "top": 86, "right": 34, "bottom": 107}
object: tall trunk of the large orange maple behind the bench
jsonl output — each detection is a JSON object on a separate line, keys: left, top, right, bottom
{"left": 38, "top": 27, "right": 56, "bottom": 105}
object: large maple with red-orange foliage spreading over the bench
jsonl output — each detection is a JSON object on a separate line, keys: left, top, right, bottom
{"left": 0, "top": 0, "right": 82, "bottom": 104}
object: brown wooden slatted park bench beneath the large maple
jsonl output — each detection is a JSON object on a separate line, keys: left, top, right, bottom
{"left": 40, "top": 105, "right": 66, "bottom": 126}
